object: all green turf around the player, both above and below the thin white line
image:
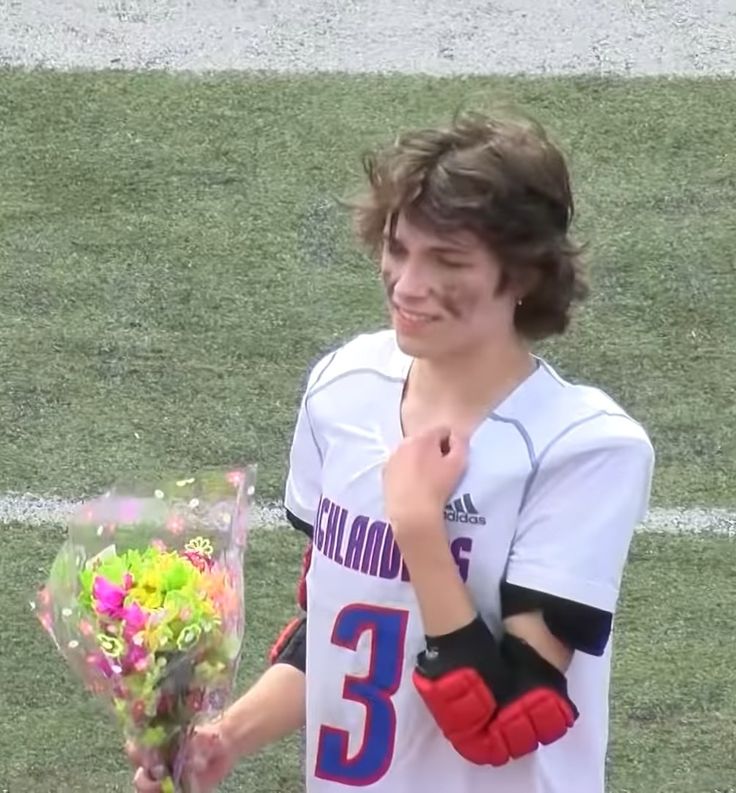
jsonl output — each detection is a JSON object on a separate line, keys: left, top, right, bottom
{"left": 0, "top": 71, "right": 736, "bottom": 793}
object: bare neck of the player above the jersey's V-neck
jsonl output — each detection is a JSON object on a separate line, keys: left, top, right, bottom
{"left": 409, "top": 339, "right": 534, "bottom": 410}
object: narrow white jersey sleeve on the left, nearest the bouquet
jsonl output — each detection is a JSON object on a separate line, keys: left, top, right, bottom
{"left": 284, "top": 356, "right": 333, "bottom": 536}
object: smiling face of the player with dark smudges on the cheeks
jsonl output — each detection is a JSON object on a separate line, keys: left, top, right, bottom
{"left": 381, "top": 214, "right": 518, "bottom": 359}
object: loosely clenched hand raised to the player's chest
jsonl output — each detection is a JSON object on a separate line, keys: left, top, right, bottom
{"left": 383, "top": 427, "right": 468, "bottom": 544}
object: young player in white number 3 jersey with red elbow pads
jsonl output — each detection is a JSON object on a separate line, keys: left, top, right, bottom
{"left": 133, "top": 110, "right": 653, "bottom": 793}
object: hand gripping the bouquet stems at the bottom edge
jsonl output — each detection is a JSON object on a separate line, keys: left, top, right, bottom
{"left": 126, "top": 721, "right": 237, "bottom": 793}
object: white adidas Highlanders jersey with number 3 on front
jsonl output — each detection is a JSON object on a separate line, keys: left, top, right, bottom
{"left": 286, "top": 331, "right": 654, "bottom": 793}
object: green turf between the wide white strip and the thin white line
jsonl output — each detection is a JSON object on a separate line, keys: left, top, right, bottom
{"left": 0, "top": 72, "right": 736, "bottom": 505}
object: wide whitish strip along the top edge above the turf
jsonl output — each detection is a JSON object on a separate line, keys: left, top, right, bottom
{"left": 0, "top": 0, "right": 736, "bottom": 75}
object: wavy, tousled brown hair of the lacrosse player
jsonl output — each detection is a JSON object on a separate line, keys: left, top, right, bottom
{"left": 346, "top": 107, "right": 588, "bottom": 339}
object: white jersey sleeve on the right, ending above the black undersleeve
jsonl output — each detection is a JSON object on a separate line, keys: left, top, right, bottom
{"left": 505, "top": 415, "right": 654, "bottom": 614}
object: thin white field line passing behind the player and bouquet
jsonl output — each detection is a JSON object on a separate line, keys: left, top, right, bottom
{"left": 0, "top": 493, "right": 736, "bottom": 538}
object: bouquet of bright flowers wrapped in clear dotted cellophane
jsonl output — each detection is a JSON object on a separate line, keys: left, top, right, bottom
{"left": 31, "top": 467, "right": 255, "bottom": 793}
